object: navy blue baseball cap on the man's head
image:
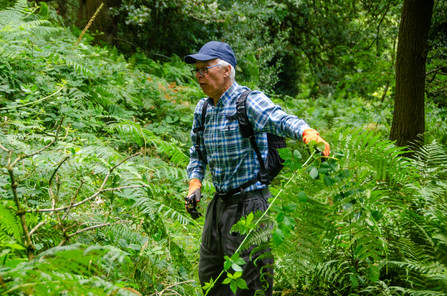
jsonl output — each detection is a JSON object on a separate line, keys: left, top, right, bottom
{"left": 185, "top": 41, "right": 237, "bottom": 69}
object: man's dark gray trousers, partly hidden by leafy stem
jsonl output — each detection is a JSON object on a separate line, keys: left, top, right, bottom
{"left": 199, "top": 189, "right": 274, "bottom": 296}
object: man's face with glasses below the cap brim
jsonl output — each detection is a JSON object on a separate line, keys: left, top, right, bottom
{"left": 195, "top": 59, "right": 229, "bottom": 101}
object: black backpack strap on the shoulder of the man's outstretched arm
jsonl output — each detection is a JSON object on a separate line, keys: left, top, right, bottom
{"left": 236, "top": 90, "right": 265, "bottom": 171}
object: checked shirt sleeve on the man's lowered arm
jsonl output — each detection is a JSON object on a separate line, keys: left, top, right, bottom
{"left": 186, "top": 99, "right": 207, "bottom": 182}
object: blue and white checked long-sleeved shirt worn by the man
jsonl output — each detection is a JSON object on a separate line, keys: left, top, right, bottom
{"left": 187, "top": 82, "right": 310, "bottom": 192}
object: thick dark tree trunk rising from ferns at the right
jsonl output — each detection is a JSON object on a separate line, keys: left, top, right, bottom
{"left": 390, "top": 0, "right": 434, "bottom": 146}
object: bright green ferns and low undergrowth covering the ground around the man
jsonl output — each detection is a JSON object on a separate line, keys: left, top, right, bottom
{"left": 0, "top": 1, "right": 447, "bottom": 295}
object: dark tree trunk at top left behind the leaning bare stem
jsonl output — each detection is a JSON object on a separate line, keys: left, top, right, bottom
{"left": 76, "top": 0, "right": 121, "bottom": 44}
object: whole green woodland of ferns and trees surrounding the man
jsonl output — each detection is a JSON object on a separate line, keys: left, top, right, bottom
{"left": 0, "top": 0, "right": 447, "bottom": 295}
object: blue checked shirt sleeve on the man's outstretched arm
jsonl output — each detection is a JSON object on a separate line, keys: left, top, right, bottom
{"left": 246, "top": 91, "right": 310, "bottom": 141}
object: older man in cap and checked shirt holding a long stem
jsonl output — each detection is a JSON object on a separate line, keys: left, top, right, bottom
{"left": 185, "top": 41, "right": 330, "bottom": 296}
